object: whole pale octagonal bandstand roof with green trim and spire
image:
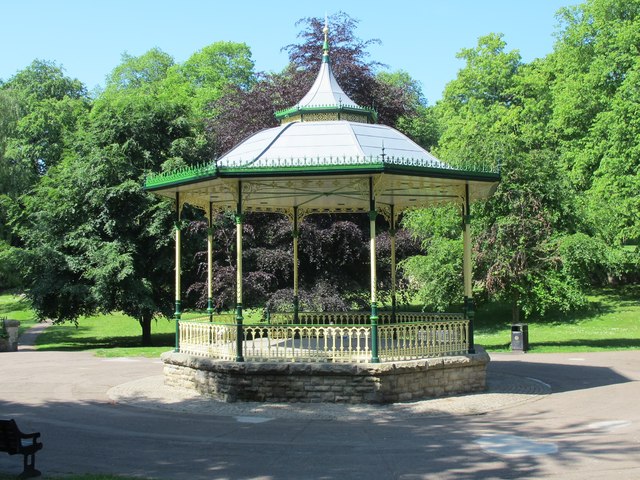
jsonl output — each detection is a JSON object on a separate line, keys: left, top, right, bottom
{"left": 145, "top": 21, "right": 500, "bottom": 215}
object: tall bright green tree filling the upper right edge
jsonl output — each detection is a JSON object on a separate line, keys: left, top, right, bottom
{"left": 549, "top": 0, "right": 640, "bottom": 278}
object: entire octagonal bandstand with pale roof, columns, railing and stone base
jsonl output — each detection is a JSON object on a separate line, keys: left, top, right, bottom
{"left": 145, "top": 25, "right": 500, "bottom": 403}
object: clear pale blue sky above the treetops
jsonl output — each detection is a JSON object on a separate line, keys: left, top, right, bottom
{"left": 0, "top": 0, "right": 580, "bottom": 103}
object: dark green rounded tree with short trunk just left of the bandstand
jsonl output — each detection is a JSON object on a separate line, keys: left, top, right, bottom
{"left": 14, "top": 148, "right": 173, "bottom": 345}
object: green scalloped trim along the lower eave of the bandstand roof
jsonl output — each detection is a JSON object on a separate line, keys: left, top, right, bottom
{"left": 144, "top": 156, "right": 500, "bottom": 191}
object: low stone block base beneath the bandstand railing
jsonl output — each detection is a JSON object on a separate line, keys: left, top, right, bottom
{"left": 162, "top": 347, "right": 489, "bottom": 403}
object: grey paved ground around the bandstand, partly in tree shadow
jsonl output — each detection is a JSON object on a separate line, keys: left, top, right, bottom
{"left": 0, "top": 340, "right": 640, "bottom": 480}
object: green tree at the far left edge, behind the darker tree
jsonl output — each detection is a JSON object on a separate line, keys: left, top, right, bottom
{"left": 0, "top": 60, "right": 90, "bottom": 288}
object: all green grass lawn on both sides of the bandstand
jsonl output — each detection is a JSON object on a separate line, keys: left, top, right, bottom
{"left": 0, "top": 285, "right": 640, "bottom": 356}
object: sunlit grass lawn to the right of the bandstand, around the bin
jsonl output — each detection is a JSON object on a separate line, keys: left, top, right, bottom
{"left": 475, "top": 285, "right": 640, "bottom": 353}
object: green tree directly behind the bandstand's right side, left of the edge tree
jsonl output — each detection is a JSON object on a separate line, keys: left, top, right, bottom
{"left": 405, "top": 34, "right": 584, "bottom": 321}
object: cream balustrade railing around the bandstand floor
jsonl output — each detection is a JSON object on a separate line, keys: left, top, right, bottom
{"left": 179, "top": 312, "right": 469, "bottom": 363}
